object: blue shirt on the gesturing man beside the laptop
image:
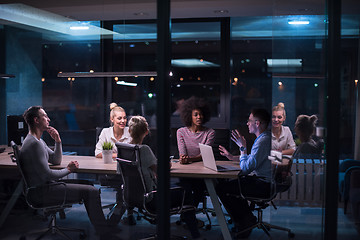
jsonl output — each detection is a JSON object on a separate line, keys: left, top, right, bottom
{"left": 240, "top": 131, "right": 271, "bottom": 181}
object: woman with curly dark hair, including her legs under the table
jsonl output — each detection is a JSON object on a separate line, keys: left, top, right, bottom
{"left": 176, "top": 97, "right": 215, "bottom": 227}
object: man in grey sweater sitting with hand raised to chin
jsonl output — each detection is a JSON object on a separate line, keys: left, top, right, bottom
{"left": 21, "top": 106, "right": 116, "bottom": 235}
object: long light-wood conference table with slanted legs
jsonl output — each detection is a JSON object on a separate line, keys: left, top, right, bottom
{"left": 0, "top": 148, "right": 239, "bottom": 240}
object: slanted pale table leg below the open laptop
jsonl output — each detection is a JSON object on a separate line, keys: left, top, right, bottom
{"left": 204, "top": 179, "right": 232, "bottom": 240}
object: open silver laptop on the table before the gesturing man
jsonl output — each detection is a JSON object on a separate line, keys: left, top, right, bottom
{"left": 199, "top": 143, "right": 240, "bottom": 172}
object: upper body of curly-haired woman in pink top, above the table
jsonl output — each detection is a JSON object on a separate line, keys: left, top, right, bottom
{"left": 176, "top": 97, "right": 215, "bottom": 164}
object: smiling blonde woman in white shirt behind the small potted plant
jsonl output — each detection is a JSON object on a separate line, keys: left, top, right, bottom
{"left": 95, "top": 103, "right": 131, "bottom": 158}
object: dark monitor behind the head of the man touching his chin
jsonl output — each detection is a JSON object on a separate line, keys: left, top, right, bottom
{"left": 6, "top": 115, "right": 28, "bottom": 146}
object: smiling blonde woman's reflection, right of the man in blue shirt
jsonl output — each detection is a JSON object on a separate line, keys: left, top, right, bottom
{"left": 271, "top": 102, "right": 296, "bottom": 155}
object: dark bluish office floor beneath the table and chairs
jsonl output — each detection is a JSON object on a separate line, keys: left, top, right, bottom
{"left": 0, "top": 186, "right": 360, "bottom": 240}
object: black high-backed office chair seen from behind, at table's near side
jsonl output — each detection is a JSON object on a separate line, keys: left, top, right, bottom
{"left": 116, "top": 143, "right": 194, "bottom": 239}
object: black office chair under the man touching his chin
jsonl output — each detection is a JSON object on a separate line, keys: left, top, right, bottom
{"left": 10, "top": 141, "right": 86, "bottom": 240}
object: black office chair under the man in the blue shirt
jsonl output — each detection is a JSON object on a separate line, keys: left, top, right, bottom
{"left": 236, "top": 156, "right": 295, "bottom": 239}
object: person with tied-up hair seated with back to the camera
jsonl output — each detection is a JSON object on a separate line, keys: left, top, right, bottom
{"left": 129, "top": 116, "right": 200, "bottom": 239}
